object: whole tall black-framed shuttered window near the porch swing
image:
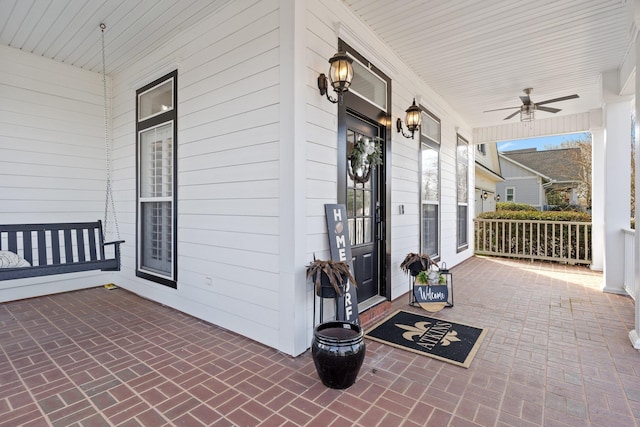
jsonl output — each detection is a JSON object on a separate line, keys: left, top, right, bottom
{"left": 136, "top": 71, "right": 178, "bottom": 288}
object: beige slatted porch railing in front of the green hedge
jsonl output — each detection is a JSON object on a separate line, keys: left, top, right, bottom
{"left": 474, "top": 218, "right": 591, "bottom": 264}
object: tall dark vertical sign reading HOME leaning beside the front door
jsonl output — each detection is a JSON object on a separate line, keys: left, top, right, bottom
{"left": 324, "top": 204, "right": 360, "bottom": 325}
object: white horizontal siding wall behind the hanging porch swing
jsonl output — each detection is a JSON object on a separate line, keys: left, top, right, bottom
{"left": 0, "top": 46, "right": 112, "bottom": 301}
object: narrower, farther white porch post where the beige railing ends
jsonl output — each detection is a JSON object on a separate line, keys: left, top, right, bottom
{"left": 591, "top": 119, "right": 605, "bottom": 271}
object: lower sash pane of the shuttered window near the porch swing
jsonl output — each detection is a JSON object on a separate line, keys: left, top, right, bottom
{"left": 140, "top": 202, "right": 173, "bottom": 276}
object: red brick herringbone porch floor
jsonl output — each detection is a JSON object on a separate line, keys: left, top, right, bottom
{"left": 0, "top": 258, "right": 640, "bottom": 427}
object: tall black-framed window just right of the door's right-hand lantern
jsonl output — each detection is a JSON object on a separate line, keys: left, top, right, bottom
{"left": 420, "top": 111, "right": 440, "bottom": 260}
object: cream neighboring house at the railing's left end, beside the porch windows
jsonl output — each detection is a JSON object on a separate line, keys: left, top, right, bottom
{"left": 474, "top": 142, "right": 504, "bottom": 216}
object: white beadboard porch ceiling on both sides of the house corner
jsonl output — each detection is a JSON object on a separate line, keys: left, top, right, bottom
{"left": 0, "top": 0, "right": 636, "bottom": 127}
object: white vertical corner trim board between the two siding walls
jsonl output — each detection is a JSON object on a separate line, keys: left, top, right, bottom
{"left": 278, "top": 0, "right": 312, "bottom": 355}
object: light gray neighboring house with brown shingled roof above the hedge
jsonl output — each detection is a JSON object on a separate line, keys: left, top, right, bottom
{"left": 497, "top": 148, "right": 581, "bottom": 210}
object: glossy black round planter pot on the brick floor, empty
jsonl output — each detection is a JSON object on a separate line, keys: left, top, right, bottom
{"left": 311, "top": 321, "right": 366, "bottom": 389}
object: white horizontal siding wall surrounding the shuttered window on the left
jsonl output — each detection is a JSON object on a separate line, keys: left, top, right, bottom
{"left": 113, "top": 1, "right": 281, "bottom": 347}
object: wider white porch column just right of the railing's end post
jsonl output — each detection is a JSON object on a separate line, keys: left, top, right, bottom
{"left": 603, "top": 70, "right": 631, "bottom": 294}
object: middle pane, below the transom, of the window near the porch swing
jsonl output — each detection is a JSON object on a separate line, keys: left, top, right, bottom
{"left": 140, "top": 123, "right": 173, "bottom": 197}
